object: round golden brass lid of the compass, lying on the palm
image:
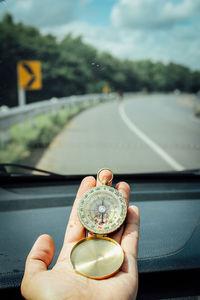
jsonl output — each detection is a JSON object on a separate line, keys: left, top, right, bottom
{"left": 70, "top": 236, "right": 124, "bottom": 279}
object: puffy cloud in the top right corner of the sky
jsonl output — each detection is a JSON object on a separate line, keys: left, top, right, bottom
{"left": 111, "top": 0, "right": 200, "bottom": 29}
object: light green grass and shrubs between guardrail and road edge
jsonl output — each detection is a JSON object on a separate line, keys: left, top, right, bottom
{"left": 0, "top": 98, "right": 100, "bottom": 164}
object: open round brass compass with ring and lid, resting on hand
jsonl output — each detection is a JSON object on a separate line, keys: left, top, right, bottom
{"left": 70, "top": 169, "right": 127, "bottom": 279}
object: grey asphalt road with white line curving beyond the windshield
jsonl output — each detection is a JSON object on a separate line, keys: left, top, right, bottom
{"left": 37, "top": 94, "right": 200, "bottom": 174}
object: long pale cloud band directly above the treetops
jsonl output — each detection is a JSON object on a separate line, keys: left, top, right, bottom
{"left": 43, "top": 20, "right": 200, "bottom": 69}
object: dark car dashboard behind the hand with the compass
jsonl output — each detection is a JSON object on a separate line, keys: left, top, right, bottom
{"left": 0, "top": 172, "right": 200, "bottom": 299}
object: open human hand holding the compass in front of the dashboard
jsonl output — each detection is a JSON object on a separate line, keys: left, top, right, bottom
{"left": 21, "top": 170, "right": 139, "bottom": 300}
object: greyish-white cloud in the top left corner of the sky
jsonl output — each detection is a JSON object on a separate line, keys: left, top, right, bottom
{"left": 0, "top": 0, "right": 76, "bottom": 27}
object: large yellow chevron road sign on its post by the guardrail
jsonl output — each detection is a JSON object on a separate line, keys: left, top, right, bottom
{"left": 17, "top": 60, "right": 42, "bottom": 106}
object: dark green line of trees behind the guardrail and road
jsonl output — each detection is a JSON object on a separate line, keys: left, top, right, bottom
{"left": 0, "top": 14, "right": 200, "bottom": 107}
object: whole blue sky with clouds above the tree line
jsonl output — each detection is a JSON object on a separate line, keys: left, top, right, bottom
{"left": 0, "top": 0, "right": 200, "bottom": 70}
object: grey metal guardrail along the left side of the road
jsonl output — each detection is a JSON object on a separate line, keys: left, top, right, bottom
{"left": 0, "top": 94, "right": 115, "bottom": 143}
